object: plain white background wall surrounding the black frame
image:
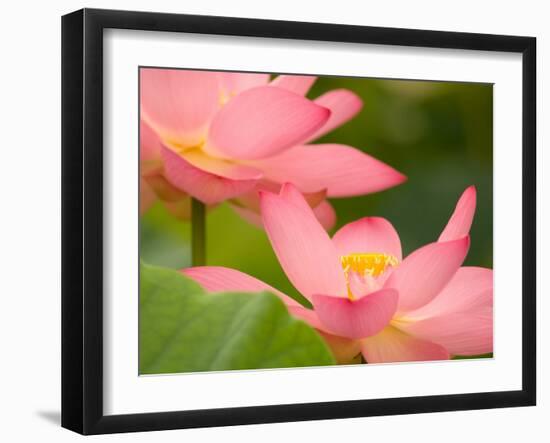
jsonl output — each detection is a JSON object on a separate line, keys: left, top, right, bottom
{"left": 0, "top": 0, "right": 550, "bottom": 443}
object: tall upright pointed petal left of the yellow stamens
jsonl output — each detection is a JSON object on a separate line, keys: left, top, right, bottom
{"left": 260, "top": 185, "right": 347, "bottom": 304}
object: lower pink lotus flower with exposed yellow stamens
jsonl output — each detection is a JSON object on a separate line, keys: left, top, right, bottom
{"left": 182, "top": 185, "right": 493, "bottom": 363}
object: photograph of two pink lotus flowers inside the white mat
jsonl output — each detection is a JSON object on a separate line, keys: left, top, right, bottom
{"left": 139, "top": 66, "right": 496, "bottom": 375}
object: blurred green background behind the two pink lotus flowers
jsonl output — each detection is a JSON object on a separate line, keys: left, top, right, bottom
{"left": 140, "top": 77, "right": 493, "bottom": 308}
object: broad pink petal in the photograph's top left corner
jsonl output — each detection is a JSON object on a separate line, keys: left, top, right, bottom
{"left": 140, "top": 68, "right": 220, "bottom": 147}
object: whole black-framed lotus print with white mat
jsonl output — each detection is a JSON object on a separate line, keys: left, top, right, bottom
{"left": 62, "top": 9, "right": 536, "bottom": 434}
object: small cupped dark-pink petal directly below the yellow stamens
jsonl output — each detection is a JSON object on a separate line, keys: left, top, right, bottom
{"left": 312, "top": 289, "right": 398, "bottom": 338}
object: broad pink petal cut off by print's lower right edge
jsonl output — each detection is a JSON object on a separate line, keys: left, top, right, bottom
{"left": 399, "top": 267, "right": 493, "bottom": 355}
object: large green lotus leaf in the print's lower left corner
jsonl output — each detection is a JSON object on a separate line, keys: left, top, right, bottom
{"left": 139, "top": 264, "right": 336, "bottom": 374}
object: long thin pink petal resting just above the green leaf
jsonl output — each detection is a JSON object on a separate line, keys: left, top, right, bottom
{"left": 181, "top": 266, "right": 301, "bottom": 306}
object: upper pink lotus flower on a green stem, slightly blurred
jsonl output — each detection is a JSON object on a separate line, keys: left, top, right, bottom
{"left": 140, "top": 69, "right": 405, "bottom": 226}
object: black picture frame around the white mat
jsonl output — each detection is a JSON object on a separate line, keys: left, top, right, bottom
{"left": 62, "top": 9, "right": 536, "bottom": 434}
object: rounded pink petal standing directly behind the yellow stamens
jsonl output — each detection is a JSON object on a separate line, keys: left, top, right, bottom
{"left": 332, "top": 217, "right": 402, "bottom": 261}
